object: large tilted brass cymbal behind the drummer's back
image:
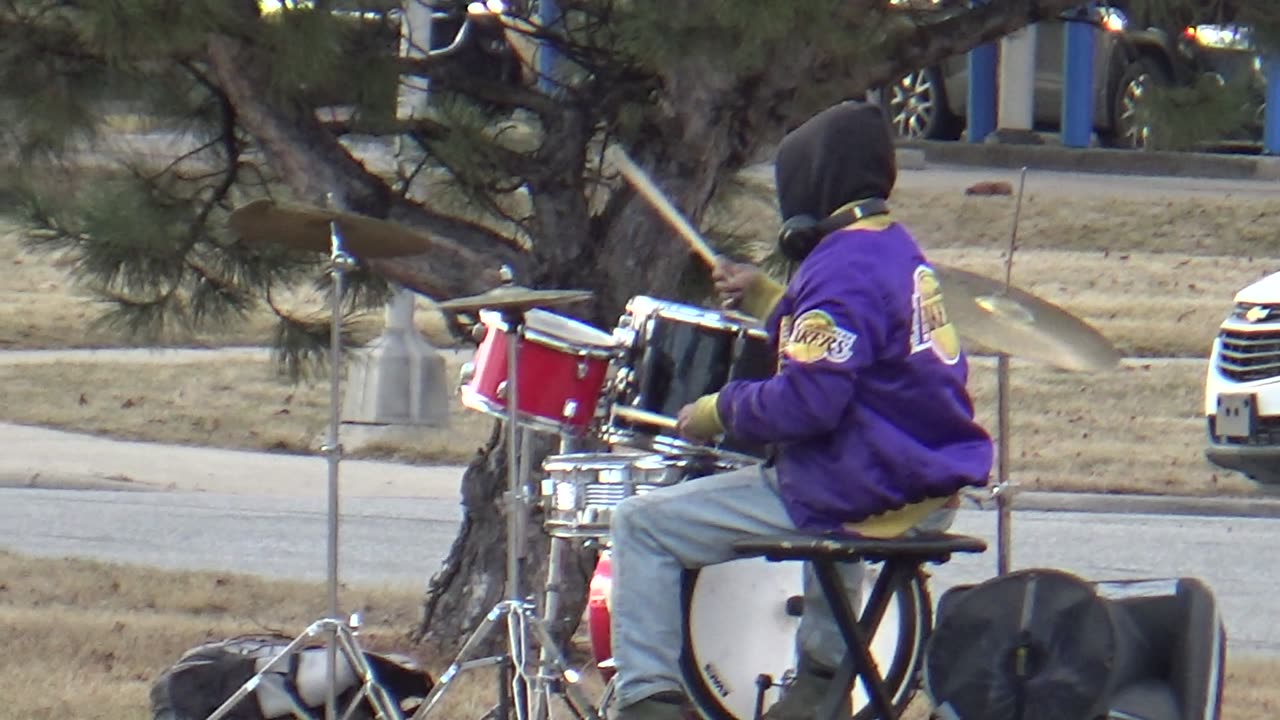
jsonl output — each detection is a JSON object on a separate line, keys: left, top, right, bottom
{"left": 934, "top": 265, "right": 1120, "bottom": 372}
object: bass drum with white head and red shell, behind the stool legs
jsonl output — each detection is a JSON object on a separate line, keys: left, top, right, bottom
{"left": 588, "top": 553, "right": 933, "bottom": 720}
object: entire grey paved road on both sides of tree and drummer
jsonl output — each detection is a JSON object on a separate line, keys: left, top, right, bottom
{"left": 0, "top": 488, "right": 1280, "bottom": 655}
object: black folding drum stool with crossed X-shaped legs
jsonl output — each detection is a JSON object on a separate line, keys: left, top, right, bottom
{"left": 733, "top": 533, "right": 987, "bottom": 720}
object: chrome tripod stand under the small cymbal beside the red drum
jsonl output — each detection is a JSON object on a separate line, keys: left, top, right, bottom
{"left": 412, "top": 302, "right": 600, "bottom": 720}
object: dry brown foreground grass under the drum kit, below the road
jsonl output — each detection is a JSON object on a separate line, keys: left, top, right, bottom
{"left": 0, "top": 551, "right": 1280, "bottom": 720}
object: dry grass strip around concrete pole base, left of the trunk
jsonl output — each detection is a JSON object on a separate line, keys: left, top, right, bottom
{"left": 0, "top": 359, "right": 493, "bottom": 462}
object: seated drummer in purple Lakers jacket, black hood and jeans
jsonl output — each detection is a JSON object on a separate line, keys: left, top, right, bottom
{"left": 611, "top": 102, "right": 992, "bottom": 720}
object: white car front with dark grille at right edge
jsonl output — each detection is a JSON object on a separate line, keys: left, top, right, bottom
{"left": 1204, "top": 273, "right": 1280, "bottom": 484}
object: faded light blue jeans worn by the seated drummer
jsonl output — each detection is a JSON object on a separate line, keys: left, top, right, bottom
{"left": 611, "top": 465, "right": 955, "bottom": 707}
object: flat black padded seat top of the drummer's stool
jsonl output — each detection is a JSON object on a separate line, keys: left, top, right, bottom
{"left": 733, "top": 533, "right": 987, "bottom": 565}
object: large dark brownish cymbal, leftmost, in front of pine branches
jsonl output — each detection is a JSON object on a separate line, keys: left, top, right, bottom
{"left": 229, "top": 200, "right": 433, "bottom": 259}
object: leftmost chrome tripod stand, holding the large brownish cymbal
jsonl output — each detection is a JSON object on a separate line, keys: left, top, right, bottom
{"left": 206, "top": 220, "right": 403, "bottom": 720}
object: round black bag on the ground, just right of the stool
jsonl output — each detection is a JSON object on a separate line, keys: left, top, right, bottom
{"left": 924, "top": 569, "right": 1146, "bottom": 720}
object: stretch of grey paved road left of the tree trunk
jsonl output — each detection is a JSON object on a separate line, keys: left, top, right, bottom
{"left": 0, "top": 488, "right": 461, "bottom": 585}
